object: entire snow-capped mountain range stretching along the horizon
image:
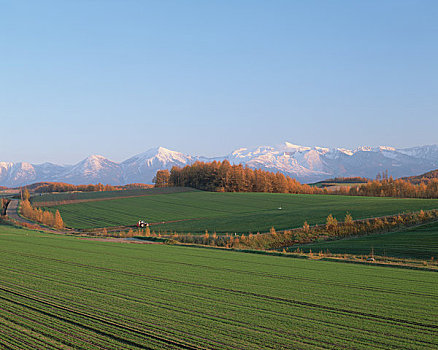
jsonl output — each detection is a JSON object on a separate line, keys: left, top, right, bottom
{"left": 0, "top": 142, "right": 438, "bottom": 187}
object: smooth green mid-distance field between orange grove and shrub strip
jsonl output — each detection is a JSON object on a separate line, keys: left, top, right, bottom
{"left": 45, "top": 191, "right": 438, "bottom": 233}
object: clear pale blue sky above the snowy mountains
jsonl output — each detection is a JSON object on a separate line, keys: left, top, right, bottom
{"left": 0, "top": 0, "right": 438, "bottom": 164}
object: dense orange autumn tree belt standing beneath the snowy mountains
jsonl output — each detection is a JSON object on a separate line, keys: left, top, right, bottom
{"left": 154, "top": 160, "right": 438, "bottom": 198}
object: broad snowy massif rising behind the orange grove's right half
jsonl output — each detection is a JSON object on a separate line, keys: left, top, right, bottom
{"left": 222, "top": 142, "right": 438, "bottom": 182}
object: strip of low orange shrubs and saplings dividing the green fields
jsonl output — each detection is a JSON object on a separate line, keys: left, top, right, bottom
{"left": 171, "top": 210, "right": 438, "bottom": 250}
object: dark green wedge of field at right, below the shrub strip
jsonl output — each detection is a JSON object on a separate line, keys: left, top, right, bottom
{"left": 293, "top": 219, "right": 438, "bottom": 259}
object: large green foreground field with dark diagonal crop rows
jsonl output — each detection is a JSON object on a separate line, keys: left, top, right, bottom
{"left": 0, "top": 226, "right": 438, "bottom": 349}
